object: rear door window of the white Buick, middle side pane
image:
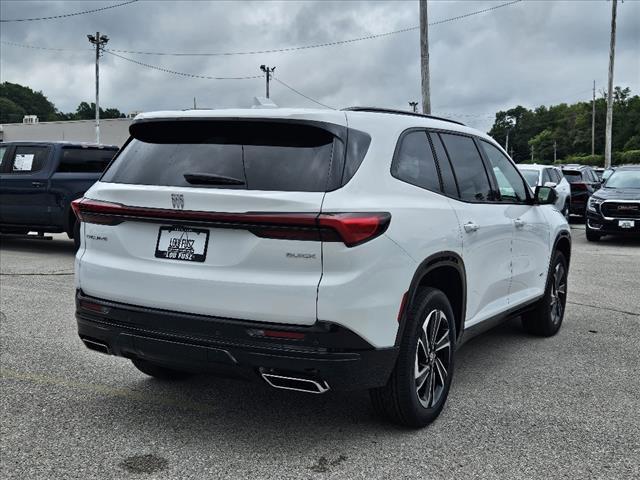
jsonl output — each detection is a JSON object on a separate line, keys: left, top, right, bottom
{"left": 440, "top": 133, "right": 493, "bottom": 202}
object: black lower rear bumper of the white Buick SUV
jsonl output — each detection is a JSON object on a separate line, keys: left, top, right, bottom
{"left": 76, "top": 291, "right": 397, "bottom": 390}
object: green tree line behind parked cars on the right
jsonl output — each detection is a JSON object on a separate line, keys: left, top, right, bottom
{"left": 489, "top": 87, "right": 640, "bottom": 165}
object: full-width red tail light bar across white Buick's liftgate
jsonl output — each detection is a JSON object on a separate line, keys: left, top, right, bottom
{"left": 71, "top": 198, "right": 391, "bottom": 247}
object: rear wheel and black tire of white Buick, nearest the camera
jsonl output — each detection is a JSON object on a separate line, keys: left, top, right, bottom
{"left": 369, "top": 288, "right": 456, "bottom": 428}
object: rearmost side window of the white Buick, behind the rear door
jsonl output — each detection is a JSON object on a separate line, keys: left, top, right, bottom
{"left": 391, "top": 131, "right": 440, "bottom": 191}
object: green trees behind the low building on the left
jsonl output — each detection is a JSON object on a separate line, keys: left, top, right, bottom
{"left": 0, "top": 82, "right": 125, "bottom": 123}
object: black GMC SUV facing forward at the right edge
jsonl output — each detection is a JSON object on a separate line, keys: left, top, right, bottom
{"left": 586, "top": 165, "right": 640, "bottom": 242}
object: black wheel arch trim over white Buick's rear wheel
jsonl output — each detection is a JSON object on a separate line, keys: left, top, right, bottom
{"left": 396, "top": 251, "right": 467, "bottom": 345}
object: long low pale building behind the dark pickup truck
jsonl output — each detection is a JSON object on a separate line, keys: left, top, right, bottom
{"left": 0, "top": 118, "right": 133, "bottom": 147}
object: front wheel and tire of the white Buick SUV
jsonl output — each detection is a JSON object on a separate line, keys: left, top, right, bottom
{"left": 522, "top": 252, "right": 569, "bottom": 337}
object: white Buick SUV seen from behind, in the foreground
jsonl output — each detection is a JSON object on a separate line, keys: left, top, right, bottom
{"left": 74, "top": 108, "right": 571, "bottom": 426}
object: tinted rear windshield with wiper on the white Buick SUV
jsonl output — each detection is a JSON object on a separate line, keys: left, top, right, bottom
{"left": 102, "top": 121, "right": 338, "bottom": 192}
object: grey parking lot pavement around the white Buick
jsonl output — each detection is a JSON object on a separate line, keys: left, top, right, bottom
{"left": 0, "top": 231, "right": 640, "bottom": 479}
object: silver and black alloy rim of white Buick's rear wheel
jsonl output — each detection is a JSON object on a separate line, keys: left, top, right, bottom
{"left": 414, "top": 309, "right": 451, "bottom": 408}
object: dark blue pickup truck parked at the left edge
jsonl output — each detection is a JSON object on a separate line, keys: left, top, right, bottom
{"left": 0, "top": 142, "right": 118, "bottom": 247}
